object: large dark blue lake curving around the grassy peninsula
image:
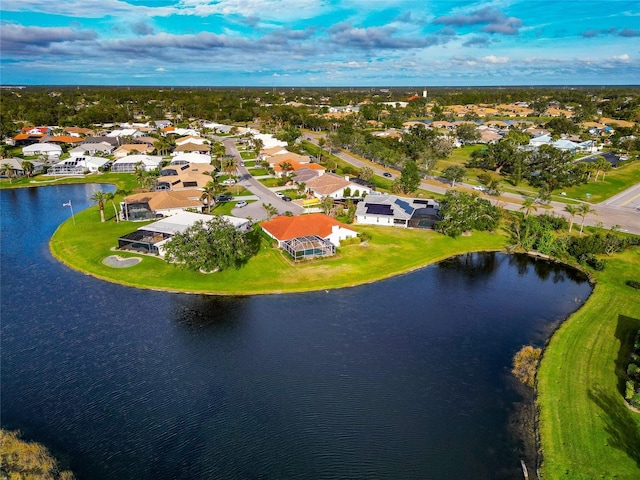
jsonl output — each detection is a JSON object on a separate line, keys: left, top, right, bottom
{"left": 0, "top": 186, "right": 590, "bottom": 479}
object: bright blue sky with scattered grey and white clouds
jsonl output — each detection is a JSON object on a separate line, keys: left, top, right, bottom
{"left": 0, "top": 0, "right": 640, "bottom": 86}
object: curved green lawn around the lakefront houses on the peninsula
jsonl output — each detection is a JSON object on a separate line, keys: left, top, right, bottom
{"left": 50, "top": 207, "right": 506, "bottom": 295}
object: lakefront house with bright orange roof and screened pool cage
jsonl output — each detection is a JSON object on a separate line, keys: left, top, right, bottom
{"left": 260, "top": 213, "right": 358, "bottom": 261}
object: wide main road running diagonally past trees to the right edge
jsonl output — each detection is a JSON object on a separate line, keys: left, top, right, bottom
{"left": 305, "top": 132, "right": 640, "bottom": 235}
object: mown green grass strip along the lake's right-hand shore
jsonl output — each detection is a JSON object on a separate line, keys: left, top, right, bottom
{"left": 538, "top": 248, "right": 640, "bottom": 480}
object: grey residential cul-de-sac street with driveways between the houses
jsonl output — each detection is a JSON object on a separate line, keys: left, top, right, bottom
{"left": 222, "top": 138, "right": 304, "bottom": 221}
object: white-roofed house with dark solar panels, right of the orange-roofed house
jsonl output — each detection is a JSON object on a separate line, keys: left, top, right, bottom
{"left": 356, "top": 195, "right": 440, "bottom": 228}
